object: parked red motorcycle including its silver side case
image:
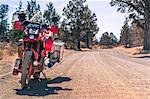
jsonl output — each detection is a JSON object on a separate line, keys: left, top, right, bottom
{"left": 13, "top": 21, "right": 64, "bottom": 87}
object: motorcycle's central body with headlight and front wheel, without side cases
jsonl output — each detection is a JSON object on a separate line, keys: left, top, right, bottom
{"left": 20, "top": 22, "right": 43, "bottom": 87}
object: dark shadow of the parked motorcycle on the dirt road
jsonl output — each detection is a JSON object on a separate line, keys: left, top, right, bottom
{"left": 14, "top": 77, "right": 72, "bottom": 96}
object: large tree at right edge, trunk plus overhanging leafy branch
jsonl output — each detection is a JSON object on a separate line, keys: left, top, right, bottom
{"left": 110, "top": 0, "right": 150, "bottom": 50}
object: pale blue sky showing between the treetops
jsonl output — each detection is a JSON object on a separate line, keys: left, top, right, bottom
{"left": 0, "top": 0, "right": 125, "bottom": 39}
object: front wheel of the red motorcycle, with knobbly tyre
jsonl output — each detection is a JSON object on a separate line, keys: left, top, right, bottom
{"left": 21, "top": 50, "right": 32, "bottom": 88}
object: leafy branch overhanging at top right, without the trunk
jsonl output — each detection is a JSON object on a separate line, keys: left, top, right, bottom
{"left": 110, "top": 0, "right": 145, "bottom": 28}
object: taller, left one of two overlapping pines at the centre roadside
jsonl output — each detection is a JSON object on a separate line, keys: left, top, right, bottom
{"left": 63, "top": 0, "right": 85, "bottom": 50}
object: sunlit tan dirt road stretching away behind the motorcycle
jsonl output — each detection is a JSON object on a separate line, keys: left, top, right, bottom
{"left": 0, "top": 49, "right": 150, "bottom": 99}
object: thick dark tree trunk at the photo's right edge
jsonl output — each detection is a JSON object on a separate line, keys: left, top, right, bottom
{"left": 144, "top": 2, "right": 150, "bottom": 50}
